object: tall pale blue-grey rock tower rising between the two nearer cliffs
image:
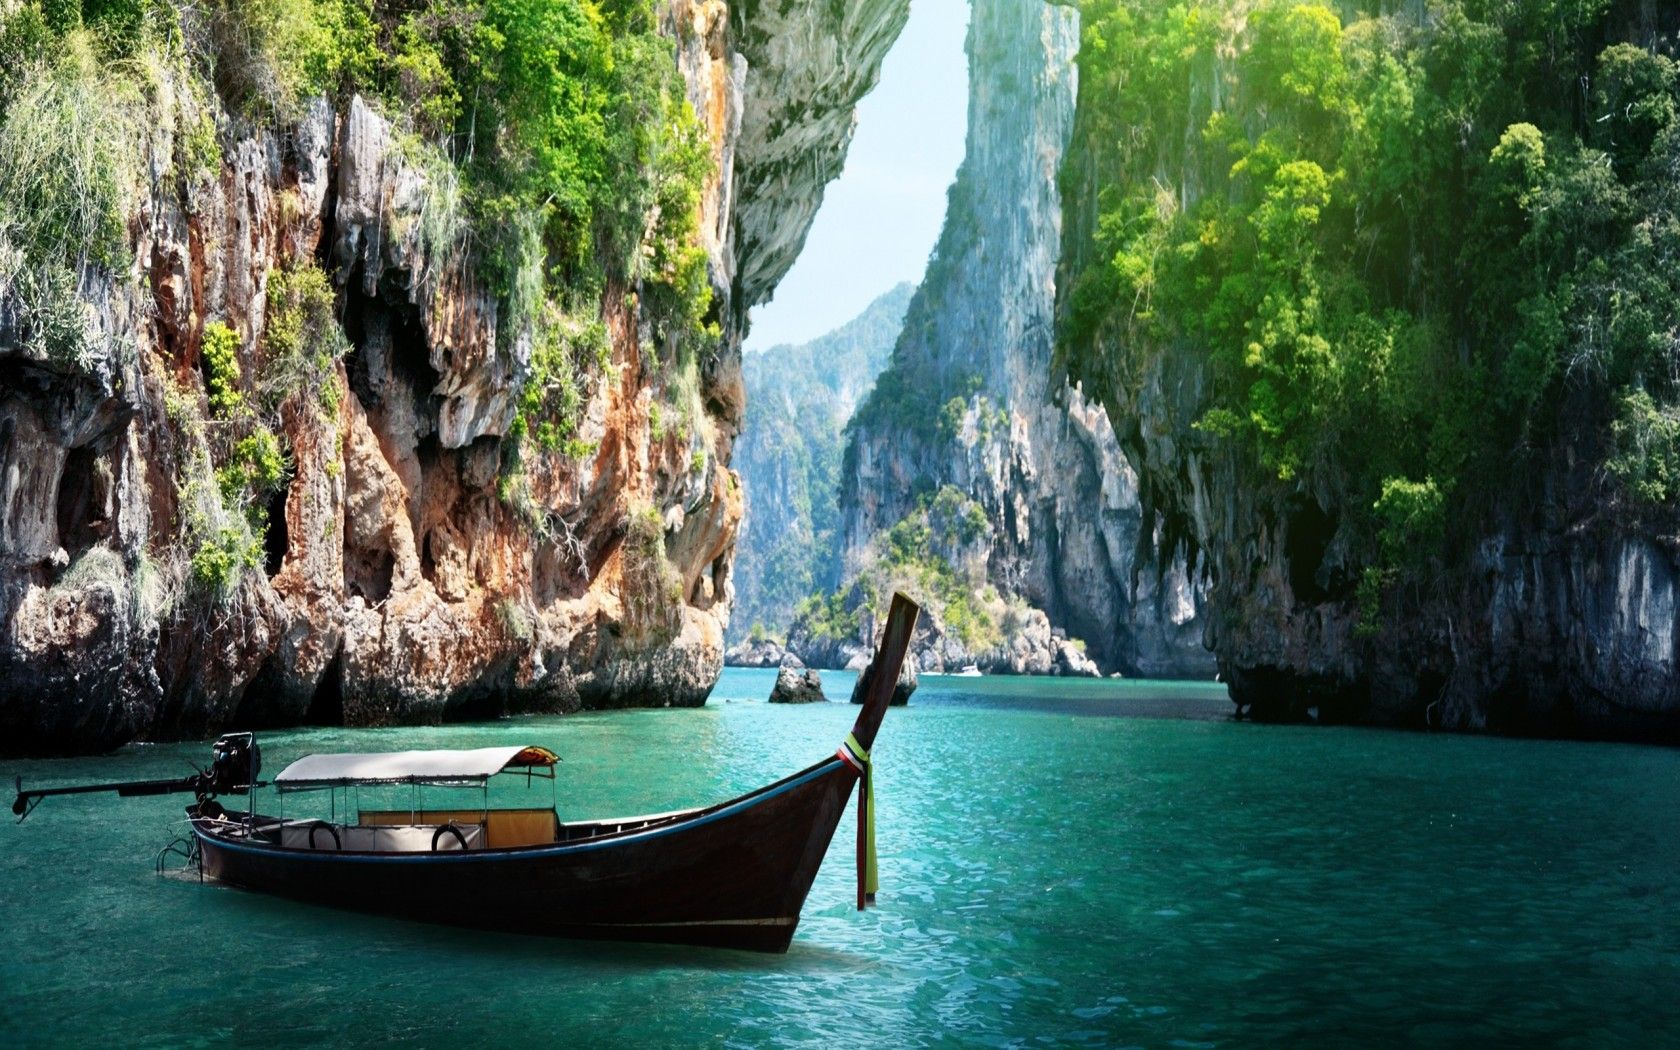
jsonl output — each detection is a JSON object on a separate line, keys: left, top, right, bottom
{"left": 828, "top": 0, "right": 1211, "bottom": 675}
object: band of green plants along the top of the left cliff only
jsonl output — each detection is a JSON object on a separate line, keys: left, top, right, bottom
{"left": 0, "top": 0, "right": 716, "bottom": 351}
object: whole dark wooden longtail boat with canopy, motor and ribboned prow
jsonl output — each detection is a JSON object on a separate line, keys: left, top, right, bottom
{"left": 12, "top": 595, "right": 917, "bottom": 951}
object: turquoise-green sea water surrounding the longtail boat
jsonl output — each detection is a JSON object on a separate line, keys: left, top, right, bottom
{"left": 0, "top": 670, "right": 1680, "bottom": 1047}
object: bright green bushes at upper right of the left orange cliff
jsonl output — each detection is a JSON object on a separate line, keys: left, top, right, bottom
{"left": 454, "top": 0, "right": 711, "bottom": 319}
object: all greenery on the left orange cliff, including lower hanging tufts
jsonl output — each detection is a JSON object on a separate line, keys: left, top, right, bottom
{"left": 0, "top": 0, "right": 717, "bottom": 621}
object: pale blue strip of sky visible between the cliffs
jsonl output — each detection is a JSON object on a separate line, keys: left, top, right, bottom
{"left": 746, "top": 0, "right": 968, "bottom": 351}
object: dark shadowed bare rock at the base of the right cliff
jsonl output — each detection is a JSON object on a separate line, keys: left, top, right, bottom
{"left": 1068, "top": 319, "right": 1680, "bottom": 739}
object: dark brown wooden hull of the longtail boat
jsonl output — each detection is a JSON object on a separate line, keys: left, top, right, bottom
{"left": 190, "top": 759, "right": 857, "bottom": 953}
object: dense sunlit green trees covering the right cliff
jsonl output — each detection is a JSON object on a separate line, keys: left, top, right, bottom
{"left": 1062, "top": 0, "right": 1680, "bottom": 614}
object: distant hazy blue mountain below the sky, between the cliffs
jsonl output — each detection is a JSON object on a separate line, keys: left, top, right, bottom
{"left": 729, "top": 284, "right": 914, "bottom": 640}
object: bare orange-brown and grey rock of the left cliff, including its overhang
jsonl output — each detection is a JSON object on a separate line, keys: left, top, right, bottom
{"left": 0, "top": 0, "right": 907, "bottom": 753}
